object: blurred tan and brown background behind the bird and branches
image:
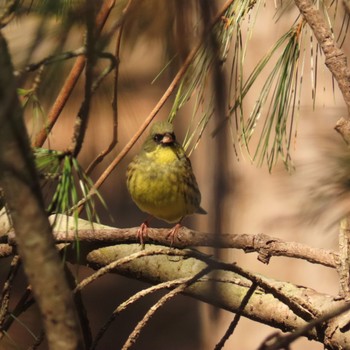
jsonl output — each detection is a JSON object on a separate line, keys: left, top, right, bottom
{"left": 0, "top": 0, "right": 349, "bottom": 350}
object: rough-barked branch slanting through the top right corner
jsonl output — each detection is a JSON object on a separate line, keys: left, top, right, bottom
{"left": 294, "top": 0, "right": 350, "bottom": 113}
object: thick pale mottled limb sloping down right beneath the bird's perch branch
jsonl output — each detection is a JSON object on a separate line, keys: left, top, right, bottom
{"left": 87, "top": 245, "right": 349, "bottom": 348}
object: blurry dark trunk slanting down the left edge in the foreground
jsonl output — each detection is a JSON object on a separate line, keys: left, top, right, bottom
{"left": 0, "top": 32, "right": 82, "bottom": 350}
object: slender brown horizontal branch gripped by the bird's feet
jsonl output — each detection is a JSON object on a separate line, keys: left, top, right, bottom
{"left": 4, "top": 224, "right": 339, "bottom": 268}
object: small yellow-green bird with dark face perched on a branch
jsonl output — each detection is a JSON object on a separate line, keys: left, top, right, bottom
{"left": 127, "top": 121, "right": 206, "bottom": 245}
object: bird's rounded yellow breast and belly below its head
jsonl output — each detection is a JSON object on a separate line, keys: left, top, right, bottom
{"left": 127, "top": 147, "right": 200, "bottom": 222}
